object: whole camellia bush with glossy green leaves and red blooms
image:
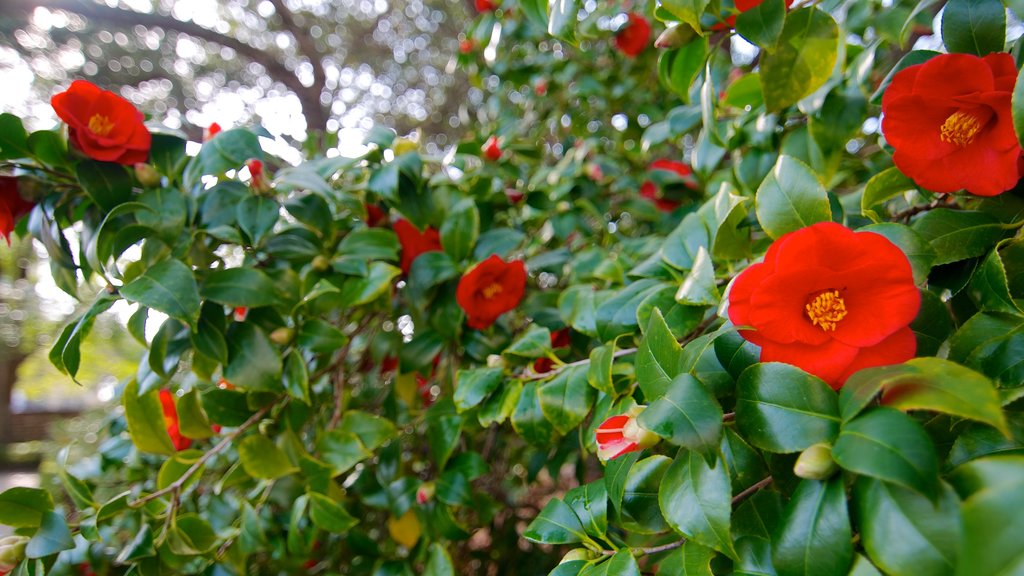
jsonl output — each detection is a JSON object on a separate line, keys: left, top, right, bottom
{"left": 0, "top": 0, "right": 1024, "bottom": 576}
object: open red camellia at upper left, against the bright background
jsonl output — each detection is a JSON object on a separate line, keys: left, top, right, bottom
{"left": 50, "top": 80, "right": 153, "bottom": 166}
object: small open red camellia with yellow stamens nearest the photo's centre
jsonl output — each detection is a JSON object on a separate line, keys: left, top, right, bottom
{"left": 455, "top": 254, "right": 526, "bottom": 330}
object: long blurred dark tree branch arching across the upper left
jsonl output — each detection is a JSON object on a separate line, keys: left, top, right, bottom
{"left": 4, "top": 0, "right": 323, "bottom": 130}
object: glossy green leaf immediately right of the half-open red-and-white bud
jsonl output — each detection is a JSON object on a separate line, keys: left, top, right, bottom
{"left": 638, "top": 373, "right": 722, "bottom": 463}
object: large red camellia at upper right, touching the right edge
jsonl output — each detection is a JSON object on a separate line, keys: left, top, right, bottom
{"left": 882, "top": 53, "right": 1024, "bottom": 196}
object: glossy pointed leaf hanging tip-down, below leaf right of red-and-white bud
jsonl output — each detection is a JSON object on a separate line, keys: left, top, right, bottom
{"left": 657, "top": 448, "right": 736, "bottom": 559}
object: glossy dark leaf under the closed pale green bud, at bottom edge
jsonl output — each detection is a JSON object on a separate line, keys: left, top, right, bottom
{"left": 772, "top": 478, "right": 853, "bottom": 576}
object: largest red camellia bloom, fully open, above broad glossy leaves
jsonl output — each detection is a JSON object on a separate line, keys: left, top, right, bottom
{"left": 729, "top": 222, "right": 921, "bottom": 389}
